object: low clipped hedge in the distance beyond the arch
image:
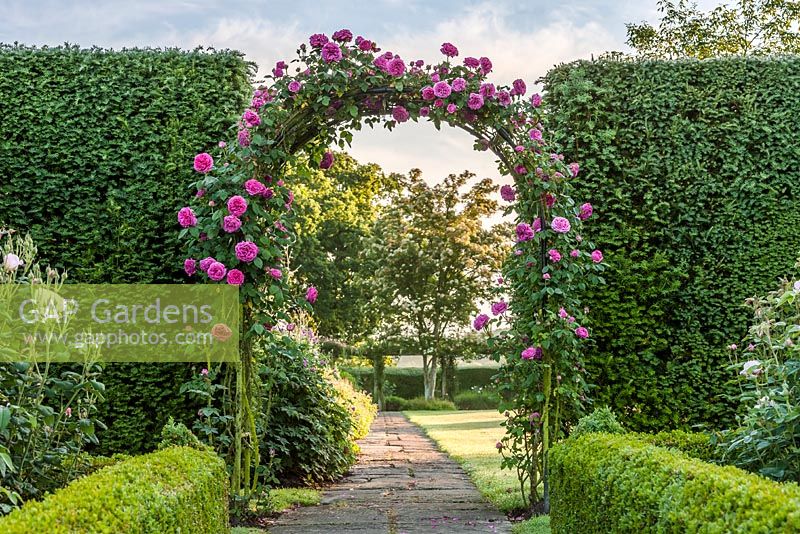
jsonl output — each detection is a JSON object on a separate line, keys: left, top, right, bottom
{"left": 344, "top": 367, "right": 497, "bottom": 399}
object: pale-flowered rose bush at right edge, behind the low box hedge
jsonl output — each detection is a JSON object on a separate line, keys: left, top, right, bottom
{"left": 719, "top": 261, "right": 800, "bottom": 482}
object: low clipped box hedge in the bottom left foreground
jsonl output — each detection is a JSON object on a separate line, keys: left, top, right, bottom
{"left": 0, "top": 447, "right": 229, "bottom": 534}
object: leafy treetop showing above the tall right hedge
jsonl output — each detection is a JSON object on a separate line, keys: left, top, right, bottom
{"left": 626, "top": 0, "right": 800, "bottom": 59}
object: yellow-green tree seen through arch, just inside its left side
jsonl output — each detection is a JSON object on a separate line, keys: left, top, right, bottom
{"left": 288, "top": 153, "right": 395, "bottom": 345}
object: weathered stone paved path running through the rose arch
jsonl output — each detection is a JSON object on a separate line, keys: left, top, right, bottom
{"left": 269, "top": 412, "right": 511, "bottom": 534}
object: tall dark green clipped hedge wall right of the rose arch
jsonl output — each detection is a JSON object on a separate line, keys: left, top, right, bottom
{"left": 545, "top": 57, "right": 800, "bottom": 436}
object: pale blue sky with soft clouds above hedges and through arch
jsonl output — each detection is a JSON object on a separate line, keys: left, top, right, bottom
{"left": 0, "top": 0, "right": 717, "bottom": 196}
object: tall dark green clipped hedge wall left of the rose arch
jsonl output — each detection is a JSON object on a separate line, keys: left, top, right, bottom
{"left": 0, "top": 46, "right": 251, "bottom": 453}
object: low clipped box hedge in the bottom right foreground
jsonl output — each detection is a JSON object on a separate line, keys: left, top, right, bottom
{"left": 549, "top": 434, "right": 800, "bottom": 534}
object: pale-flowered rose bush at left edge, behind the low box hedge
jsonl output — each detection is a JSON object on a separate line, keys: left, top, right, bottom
{"left": 0, "top": 234, "right": 105, "bottom": 515}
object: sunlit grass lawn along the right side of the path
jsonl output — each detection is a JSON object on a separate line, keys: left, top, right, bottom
{"left": 404, "top": 410, "right": 550, "bottom": 534}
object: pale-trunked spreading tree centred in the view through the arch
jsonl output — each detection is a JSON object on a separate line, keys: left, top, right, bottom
{"left": 371, "top": 169, "right": 505, "bottom": 399}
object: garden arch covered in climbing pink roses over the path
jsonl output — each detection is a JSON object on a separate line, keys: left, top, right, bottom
{"left": 178, "top": 30, "right": 603, "bottom": 512}
